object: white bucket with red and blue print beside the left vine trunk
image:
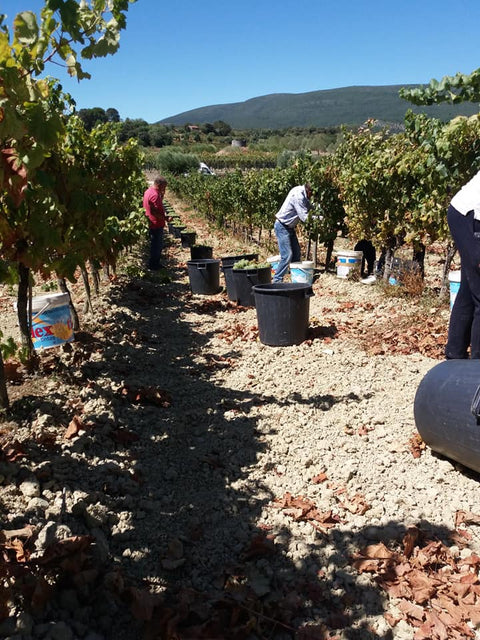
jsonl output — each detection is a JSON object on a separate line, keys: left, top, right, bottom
{"left": 15, "top": 293, "right": 73, "bottom": 349}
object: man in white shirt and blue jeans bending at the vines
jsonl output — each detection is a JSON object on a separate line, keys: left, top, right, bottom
{"left": 273, "top": 183, "right": 312, "bottom": 282}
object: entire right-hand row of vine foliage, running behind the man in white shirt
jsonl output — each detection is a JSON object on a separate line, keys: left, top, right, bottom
{"left": 169, "top": 111, "right": 480, "bottom": 284}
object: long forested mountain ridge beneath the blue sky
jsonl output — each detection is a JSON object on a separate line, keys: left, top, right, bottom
{"left": 159, "top": 84, "right": 480, "bottom": 129}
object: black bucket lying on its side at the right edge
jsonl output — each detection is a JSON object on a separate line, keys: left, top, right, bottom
{"left": 414, "top": 360, "right": 480, "bottom": 472}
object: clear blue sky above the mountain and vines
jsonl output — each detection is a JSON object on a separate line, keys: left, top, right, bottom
{"left": 0, "top": 0, "right": 480, "bottom": 123}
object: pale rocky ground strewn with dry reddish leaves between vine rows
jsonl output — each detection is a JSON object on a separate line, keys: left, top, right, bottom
{"left": 0, "top": 196, "right": 480, "bottom": 640}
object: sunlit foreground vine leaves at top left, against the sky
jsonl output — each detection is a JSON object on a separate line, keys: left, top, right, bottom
{"left": 0, "top": 0, "right": 134, "bottom": 201}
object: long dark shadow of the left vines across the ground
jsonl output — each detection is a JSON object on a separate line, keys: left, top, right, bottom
{"left": 0, "top": 242, "right": 472, "bottom": 640}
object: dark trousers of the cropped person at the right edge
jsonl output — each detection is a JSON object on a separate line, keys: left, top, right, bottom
{"left": 445, "top": 205, "right": 480, "bottom": 359}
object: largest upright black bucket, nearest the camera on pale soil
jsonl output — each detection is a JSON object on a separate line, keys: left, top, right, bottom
{"left": 253, "top": 282, "right": 314, "bottom": 347}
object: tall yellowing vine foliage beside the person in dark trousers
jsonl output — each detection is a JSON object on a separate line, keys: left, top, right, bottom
{"left": 334, "top": 112, "right": 480, "bottom": 250}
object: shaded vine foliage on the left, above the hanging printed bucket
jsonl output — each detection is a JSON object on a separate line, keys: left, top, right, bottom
{"left": 4, "top": 116, "right": 145, "bottom": 279}
